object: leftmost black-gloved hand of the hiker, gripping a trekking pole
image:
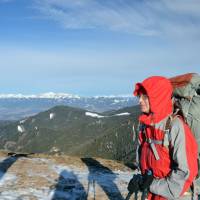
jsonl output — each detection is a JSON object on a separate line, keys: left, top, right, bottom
{"left": 127, "top": 174, "right": 142, "bottom": 193}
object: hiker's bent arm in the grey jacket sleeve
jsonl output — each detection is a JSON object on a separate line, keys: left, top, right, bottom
{"left": 150, "top": 118, "right": 190, "bottom": 199}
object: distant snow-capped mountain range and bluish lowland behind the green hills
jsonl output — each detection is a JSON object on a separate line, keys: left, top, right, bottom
{"left": 0, "top": 92, "right": 137, "bottom": 120}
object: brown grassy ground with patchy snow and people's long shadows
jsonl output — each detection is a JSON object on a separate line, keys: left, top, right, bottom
{"left": 0, "top": 154, "right": 133, "bottom": 200}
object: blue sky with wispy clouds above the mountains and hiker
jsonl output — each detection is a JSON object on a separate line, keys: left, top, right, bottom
{"left": 0, "top": 0, "right": 200, "bottom": 96}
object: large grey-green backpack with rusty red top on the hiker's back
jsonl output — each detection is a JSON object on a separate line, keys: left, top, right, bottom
{"left": 169, "top": 73, "right": 200, "bottom": 157}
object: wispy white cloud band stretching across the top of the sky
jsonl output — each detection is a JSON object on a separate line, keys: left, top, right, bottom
{"left": 33, "top": 0, "right": 200, "bottom": 36}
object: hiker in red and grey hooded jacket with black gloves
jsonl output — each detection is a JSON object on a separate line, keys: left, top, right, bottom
{"left": 128, "top": 76, "right": 198, "bottom": 200}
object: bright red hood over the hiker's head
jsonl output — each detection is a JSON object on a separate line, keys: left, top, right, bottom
{"left": 134, "top": 76, "right": 172, "bottom": 125}
